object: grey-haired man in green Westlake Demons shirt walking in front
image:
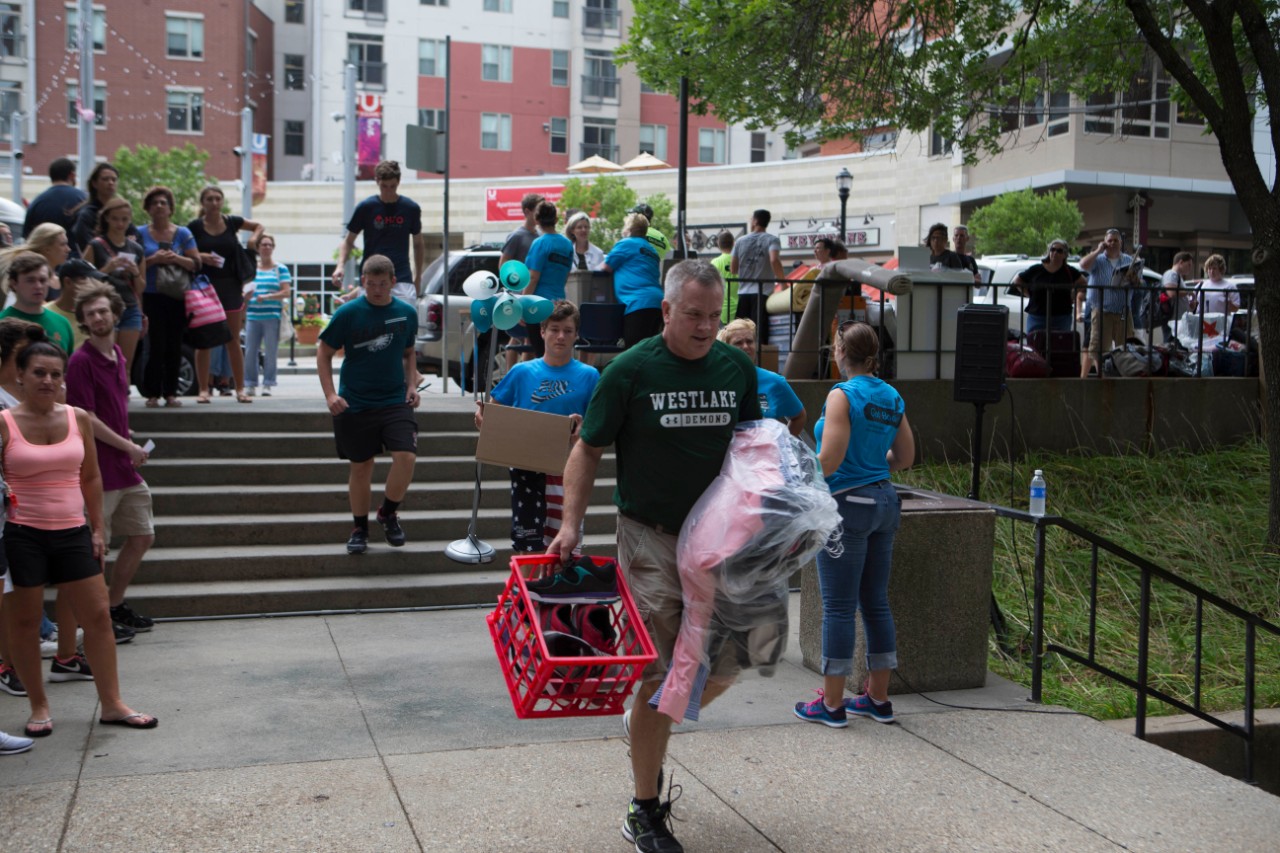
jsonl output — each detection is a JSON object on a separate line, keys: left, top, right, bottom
{"left": 547, "top": 260, "right": 760, "bottom": 853}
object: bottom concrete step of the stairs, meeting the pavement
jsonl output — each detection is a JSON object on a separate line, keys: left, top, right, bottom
{"left": 122, "top": 534, "right": 616, "bottom": 617}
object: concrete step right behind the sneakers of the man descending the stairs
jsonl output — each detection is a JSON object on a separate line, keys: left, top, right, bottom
{"left": 147, "top": 502, "right": 617, "bottom": 548}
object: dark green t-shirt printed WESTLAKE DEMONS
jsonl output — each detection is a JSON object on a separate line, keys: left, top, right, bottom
{"left": 581, "top": 334, "right": 760, "bottom": 530}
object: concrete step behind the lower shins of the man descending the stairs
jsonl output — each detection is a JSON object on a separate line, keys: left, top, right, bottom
{"left": 143, "top": 479, "right": 614, "bottom": 512}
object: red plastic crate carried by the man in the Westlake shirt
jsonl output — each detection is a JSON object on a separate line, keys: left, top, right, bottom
{"left": 486, "top": 555, "right": 658, "bottom": 720}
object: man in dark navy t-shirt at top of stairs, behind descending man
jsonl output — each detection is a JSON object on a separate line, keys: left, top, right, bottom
{"left": 333, "top": 160, "right": 426, "bottom": 307}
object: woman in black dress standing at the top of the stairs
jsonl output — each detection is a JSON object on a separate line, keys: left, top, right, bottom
{"left": 187, "top": 187, "right": 262, "bottom": 403}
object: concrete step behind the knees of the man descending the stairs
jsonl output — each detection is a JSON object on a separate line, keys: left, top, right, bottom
{"left": 145, "top": 455, "right": 613, "bottom": 489}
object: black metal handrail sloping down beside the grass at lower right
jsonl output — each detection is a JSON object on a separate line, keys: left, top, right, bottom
{"left": 989, "top": 505, "right": 1280, "bottom": 784}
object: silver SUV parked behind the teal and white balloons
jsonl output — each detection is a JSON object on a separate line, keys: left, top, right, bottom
{"left": 417, "top": 243, "right": 508, "bottom": 386}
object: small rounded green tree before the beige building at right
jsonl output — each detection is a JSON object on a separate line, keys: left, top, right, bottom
{"left": 968, "top": 188, "right": 1084, "bottom": 257}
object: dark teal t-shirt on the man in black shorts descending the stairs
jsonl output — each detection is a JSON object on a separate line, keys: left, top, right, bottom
{"left": 320, "top": 297, "right": 417, "bottom": 411}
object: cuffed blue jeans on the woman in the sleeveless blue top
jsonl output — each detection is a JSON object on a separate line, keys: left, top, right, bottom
{"left": 818, "top": 480, "right": 902, "bottom": 675}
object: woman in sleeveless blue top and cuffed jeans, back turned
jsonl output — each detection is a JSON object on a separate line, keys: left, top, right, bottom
{"left": 795, "top": 323, "right": 915, "bottom": 729}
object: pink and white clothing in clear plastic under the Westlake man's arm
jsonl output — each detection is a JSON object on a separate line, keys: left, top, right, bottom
{"left": 652, "top": 420, "right": 840, "bottom": 722}
